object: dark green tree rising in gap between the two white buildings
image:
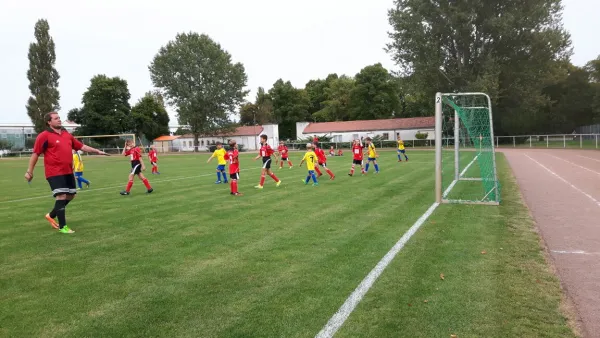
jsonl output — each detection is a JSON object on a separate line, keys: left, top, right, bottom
{"left": 269, "top": 79, "right": 311, "bottom": 139}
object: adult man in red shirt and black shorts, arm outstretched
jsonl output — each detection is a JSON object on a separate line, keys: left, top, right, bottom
{"left": 25, "top": 112, "right": 106, "bottom": 234}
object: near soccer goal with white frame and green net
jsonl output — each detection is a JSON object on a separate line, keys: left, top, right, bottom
{"left": 435, "top": 93, "right": 500, "bottom": 205}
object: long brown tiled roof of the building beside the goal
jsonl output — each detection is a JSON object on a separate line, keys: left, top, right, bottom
{"left": 303, "top": 116, "right": 435, "bottom": 134}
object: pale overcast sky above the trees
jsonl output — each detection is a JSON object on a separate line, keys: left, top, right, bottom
{"left": 0, "top": 0, "right": 600, "bottom": 125}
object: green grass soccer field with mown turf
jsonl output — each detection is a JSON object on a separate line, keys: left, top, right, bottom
{"left": 0, "top": 150, "right": 574, "bottom": 338}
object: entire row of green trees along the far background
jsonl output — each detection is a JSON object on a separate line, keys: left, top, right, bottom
{"left": 28, "top": 0, "right": 600, "bottom": 145}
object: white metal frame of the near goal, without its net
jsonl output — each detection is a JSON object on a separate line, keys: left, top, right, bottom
{"left": 435, "top": 92, "right": 500, "bottom": 205}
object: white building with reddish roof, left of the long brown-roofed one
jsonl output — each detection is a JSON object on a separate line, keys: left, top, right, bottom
{"left": 153, "top": 124, "right": 279, "bottom": 152}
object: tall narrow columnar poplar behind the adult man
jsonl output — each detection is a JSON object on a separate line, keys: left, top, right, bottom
{"left": 26, "top": 19, "right": 60, "bottom": 133}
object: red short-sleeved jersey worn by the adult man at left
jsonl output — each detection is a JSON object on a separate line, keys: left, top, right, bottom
{"left": 33, "top": 128, "right": 83, "bottom": 178}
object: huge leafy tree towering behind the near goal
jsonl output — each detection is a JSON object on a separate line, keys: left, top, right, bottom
{"left": 387, "top": 0, "right": 570, "bottom": 134}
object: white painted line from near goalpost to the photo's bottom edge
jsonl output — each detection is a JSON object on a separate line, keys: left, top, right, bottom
{"left": 316, "top": 203, "right": 439, "bottom": 338}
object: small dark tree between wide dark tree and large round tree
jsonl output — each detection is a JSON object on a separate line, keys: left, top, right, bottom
{"left": 131, "top": 92, "right": 169, "bottom": 141}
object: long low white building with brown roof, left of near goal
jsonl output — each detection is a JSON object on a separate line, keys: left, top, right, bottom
{"left": 296, "top": 116, "right": 435, "bottom": 142}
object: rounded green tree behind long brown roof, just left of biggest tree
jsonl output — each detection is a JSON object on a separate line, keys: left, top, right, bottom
{"left": 349, "top": 63, "right": 400, "bottom": 120}
